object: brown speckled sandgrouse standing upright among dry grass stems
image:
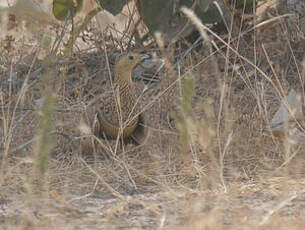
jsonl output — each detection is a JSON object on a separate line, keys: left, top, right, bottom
{"left": 85, "top": 52, "right": 148, "bottom": 144}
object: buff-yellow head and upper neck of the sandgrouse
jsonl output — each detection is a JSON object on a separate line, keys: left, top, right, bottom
{"left": 114, "top": 52, "right": 148, "bottom": 83}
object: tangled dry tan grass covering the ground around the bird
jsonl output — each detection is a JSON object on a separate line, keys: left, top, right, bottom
{"left": 0, "top": 0, "right": 305, "bottom": 230}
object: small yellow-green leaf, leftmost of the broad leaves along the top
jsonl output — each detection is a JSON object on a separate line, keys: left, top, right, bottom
{"left": 53, "top": 0, "right": 83, "bottom": 21}
